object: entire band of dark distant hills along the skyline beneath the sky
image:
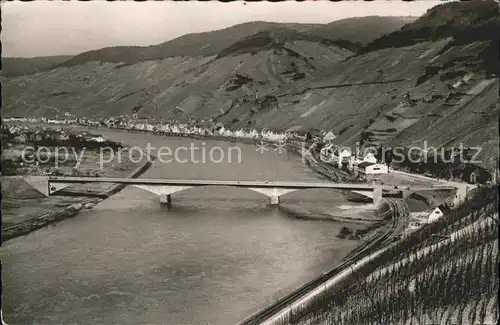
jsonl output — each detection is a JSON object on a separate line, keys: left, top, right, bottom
{"left": 2, "top": 16, "right": 415, "bottom": 76}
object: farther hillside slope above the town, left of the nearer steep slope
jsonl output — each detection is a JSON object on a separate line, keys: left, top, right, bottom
{"left": 4, "top": 36, "right": 352, "bottom": 122}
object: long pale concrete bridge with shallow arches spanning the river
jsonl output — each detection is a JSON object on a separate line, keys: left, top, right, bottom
{"left": 25, "top": 176, "right": 456, "bottom": 206}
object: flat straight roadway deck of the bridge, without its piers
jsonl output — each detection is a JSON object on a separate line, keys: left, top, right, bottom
{"left": 48, "top": 176, "right": 455, "bottom": 191}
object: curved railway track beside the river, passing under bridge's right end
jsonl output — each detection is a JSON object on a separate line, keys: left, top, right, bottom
{"left": 239, "top": 198, "right": 409, "bottom": 325}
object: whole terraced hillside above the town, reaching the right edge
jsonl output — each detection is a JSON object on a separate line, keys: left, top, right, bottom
{"left": 3, "top": 1, "right": 500, "bottom": 168}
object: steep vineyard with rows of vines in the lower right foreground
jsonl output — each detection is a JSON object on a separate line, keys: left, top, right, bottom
{"left": 279, "top": 187, "right": 499, "bottom": 325}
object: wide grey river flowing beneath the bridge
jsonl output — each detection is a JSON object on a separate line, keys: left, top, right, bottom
{"left": 1, "top": 130, "right": 368, "bottom": 324}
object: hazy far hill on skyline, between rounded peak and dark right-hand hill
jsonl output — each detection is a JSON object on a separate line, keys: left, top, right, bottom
{"left": 307, "top": 16, "right": 417, "bottom": 44}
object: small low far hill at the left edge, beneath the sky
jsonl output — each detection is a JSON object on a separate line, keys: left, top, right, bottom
{"left": 1, "top": 55, "right": 72, "bottom": 77}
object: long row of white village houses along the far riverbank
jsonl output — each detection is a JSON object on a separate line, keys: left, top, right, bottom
{"left": 2, "top": 117, "right": 400, "bottom": 179}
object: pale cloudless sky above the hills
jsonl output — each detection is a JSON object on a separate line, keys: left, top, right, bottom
{"left": 1, "top": 0, "right": 450, "bottom": 57}
